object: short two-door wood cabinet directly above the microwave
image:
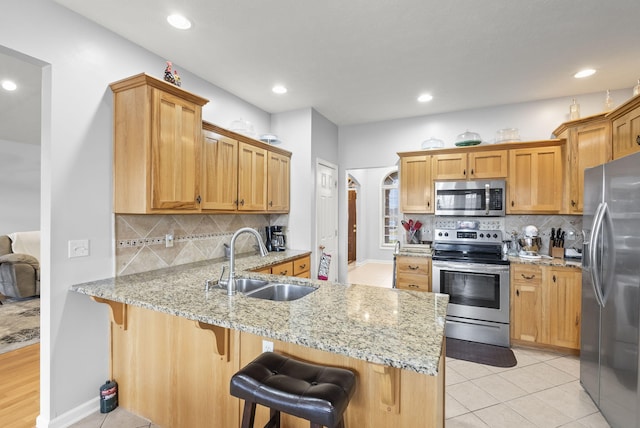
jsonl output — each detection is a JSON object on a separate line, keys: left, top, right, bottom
{"left": 431, "top": 150, "right": 509, "bottom": 180}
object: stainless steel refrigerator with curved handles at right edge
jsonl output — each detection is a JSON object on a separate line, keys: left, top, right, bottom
{"left": 580, "top": 149, "right": 640, "bottom": 428}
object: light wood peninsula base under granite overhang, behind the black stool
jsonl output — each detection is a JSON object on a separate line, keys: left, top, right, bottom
{"left": 105, "top": 302, "right": 445, "bottom": 428}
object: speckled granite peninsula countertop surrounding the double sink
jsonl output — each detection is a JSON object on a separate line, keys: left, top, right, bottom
{"left": 71, "top": 250, "right": 449, "bottom": 376}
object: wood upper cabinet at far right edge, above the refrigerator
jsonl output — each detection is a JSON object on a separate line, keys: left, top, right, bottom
{"left": 607, "top": 95, "right": 640, "bottom": 159}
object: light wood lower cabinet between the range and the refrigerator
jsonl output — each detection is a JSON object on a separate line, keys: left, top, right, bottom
{"left": 511, "top": 264, "right": 582, "bottom": 351}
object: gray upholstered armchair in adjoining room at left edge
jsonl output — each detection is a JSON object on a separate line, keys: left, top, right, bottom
{"left": 0, "top": 232, "right": 40, "bottom": 298}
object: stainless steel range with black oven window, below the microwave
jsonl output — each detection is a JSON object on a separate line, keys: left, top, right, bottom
{"left": 432, "top": 220, "right": 510, "bottom": 347}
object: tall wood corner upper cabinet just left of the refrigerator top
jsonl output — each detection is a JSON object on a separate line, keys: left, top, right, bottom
{"left": 553, "top": 113, "right": 612, "bottom": 214}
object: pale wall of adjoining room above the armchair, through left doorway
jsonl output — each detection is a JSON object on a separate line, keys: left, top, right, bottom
{"left": 0, "top": 140, "right": 40, "bottom": 235}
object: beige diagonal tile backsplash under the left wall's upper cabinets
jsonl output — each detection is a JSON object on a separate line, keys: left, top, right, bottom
{"left": 115, "top": 214, "right": 288, "bottom": 276}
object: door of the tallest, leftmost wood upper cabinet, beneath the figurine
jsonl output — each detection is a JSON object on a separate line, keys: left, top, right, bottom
{"left": 150, "top": 89, "right": 202, "bottom": 210}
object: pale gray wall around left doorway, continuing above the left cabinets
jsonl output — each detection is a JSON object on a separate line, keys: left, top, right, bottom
{"left": 0, "top": 0, "right": 270, "bottom": 427}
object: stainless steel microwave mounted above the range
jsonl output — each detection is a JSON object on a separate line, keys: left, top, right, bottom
{"left": 435, "top": 180, "right": 507, "bottom": 217}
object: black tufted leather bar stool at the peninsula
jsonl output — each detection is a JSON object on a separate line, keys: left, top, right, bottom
{"left": 231, "top": 352, "right": 356, "bottom": 428}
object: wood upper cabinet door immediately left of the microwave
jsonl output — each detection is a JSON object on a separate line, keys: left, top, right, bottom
{"left": 400, "top": 155, "right": 433, "bottom": 213}
